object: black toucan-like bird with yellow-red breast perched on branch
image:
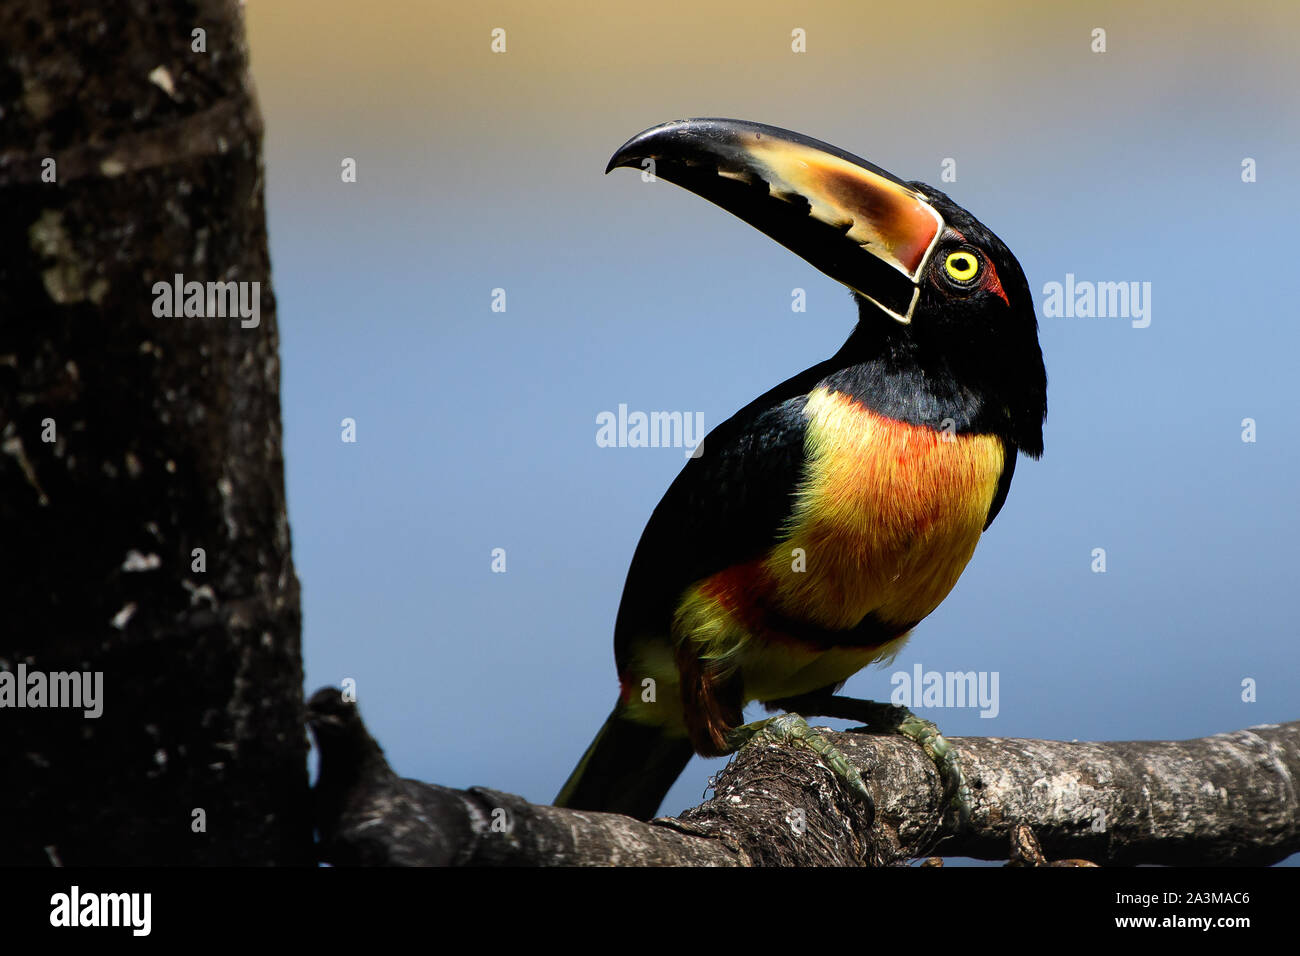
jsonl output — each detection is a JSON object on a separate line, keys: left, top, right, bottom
{"left": 555, "top": 118, "right": 1047, "bottom": 819}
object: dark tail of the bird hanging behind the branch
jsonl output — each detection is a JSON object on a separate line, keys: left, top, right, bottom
{"left": 555, "top": 708, "right": 694, "bottom": 819}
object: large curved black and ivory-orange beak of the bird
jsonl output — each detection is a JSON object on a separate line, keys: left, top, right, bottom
{"left": 605, "top": 118, "right": 944, "bottom": 323}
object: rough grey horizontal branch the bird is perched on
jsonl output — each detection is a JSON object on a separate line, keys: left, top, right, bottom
{"left": 309, "top": 689, "right": 1300, "bottom": 866}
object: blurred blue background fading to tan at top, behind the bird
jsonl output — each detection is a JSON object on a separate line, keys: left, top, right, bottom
{"left": 248, "top": 0, "right": 1300, "bottom": 863}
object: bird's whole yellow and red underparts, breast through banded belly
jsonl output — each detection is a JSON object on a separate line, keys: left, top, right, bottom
{"left": 638, "top": 388, "right": 1005, "bottom": 722}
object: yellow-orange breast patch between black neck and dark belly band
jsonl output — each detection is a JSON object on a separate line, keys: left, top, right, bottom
{"left": 767, "top": 388, "right": 1005, "bottom": 628}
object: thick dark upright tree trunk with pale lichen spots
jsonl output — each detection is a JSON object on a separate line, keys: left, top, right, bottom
{"left": 0, "top": 0, "right": 312, "bottom": 864}
